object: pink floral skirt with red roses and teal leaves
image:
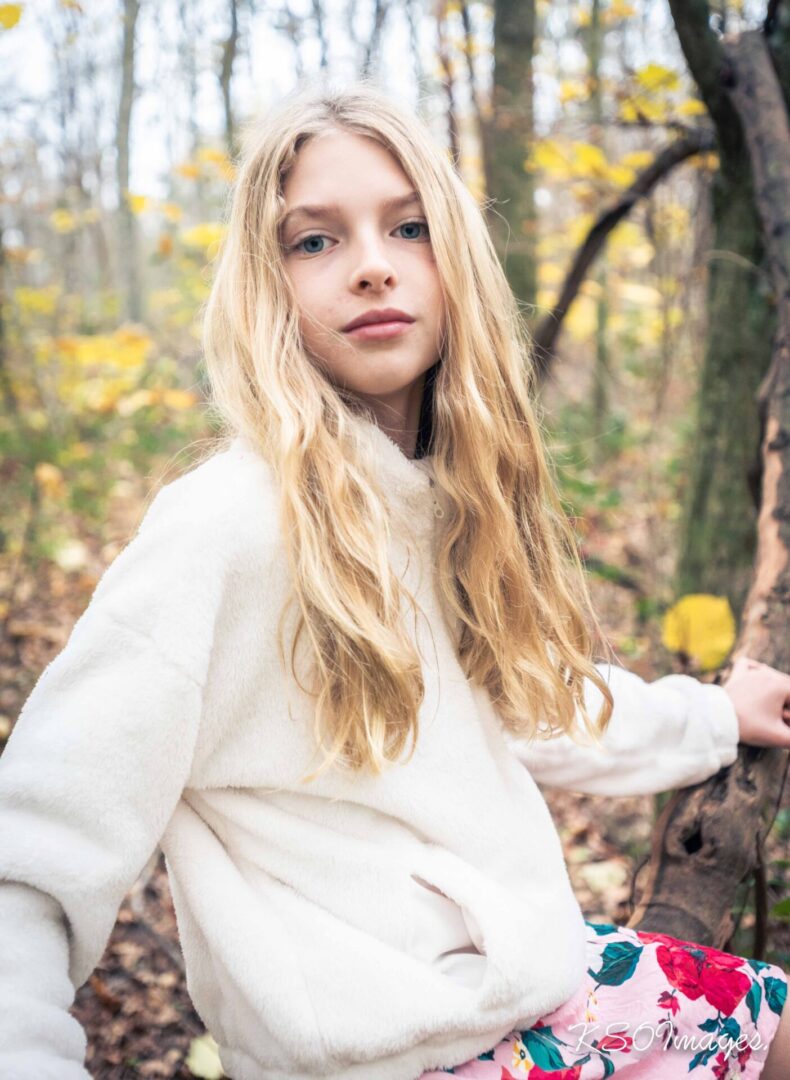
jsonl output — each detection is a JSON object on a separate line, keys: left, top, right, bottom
{"left": 420, "top": 922, "right": 788, "bottom": 1080}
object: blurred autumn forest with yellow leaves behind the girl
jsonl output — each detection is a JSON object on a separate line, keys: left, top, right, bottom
{"left": 0, "top": 0, "right": 790, "bottom": 1077}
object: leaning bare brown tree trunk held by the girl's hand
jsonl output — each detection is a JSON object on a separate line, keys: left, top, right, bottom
{"left": 629, "top": 27, "right": 790, "bottom": 953}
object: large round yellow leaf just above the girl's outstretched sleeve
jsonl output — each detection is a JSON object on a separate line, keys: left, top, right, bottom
{"left": 661, "top": 593, "right": 735, "bottom": 671}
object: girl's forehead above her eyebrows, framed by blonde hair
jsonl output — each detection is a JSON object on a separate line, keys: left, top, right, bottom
{"left": 282, "top": 129, "right": 413, "bottom": 210}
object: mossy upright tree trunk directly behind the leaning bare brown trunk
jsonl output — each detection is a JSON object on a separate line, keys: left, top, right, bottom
{"left": 670, "top": 0, "right": 775, "bottom": 616}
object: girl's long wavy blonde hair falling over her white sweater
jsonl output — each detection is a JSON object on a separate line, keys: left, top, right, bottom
{"left": 204, "top": 82, "right": 613, "bottom": 773}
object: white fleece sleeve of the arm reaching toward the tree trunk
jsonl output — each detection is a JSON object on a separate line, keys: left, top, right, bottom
{"left": 506, "top": 663, "right": 738, "bottom": 795}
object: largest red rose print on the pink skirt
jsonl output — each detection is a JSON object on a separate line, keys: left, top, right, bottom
{"left": 639, "top": 933, "right": 751, "bottom": 1016}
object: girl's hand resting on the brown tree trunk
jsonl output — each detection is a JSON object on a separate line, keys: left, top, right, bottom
{"left": 722, "top": 657, "right": 790, "bottom": 748}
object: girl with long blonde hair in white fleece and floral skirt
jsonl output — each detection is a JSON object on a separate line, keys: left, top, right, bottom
{"left": 0, "top": 79, "right": 790, "bottom": 1080}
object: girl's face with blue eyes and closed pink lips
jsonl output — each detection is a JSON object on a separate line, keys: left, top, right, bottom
{"left": 280, "top": 130, "right": 444, "bottom": 418}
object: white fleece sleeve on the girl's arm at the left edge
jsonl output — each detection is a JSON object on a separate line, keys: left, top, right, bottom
{"left": 0, "top": 477, "right": 240, "bottom": 1080}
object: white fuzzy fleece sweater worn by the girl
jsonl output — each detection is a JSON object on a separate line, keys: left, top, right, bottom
{"left": 0, "top": 421, "right": 737, "bottom": 1080}
